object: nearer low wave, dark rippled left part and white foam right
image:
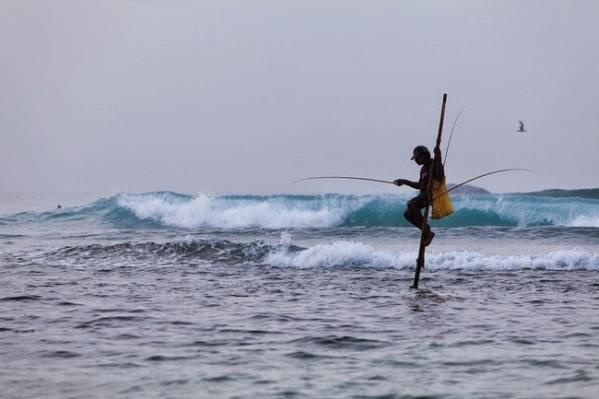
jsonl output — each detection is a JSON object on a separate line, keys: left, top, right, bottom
{"left": 9, "top": 238, "right": 599, "bottom": 271}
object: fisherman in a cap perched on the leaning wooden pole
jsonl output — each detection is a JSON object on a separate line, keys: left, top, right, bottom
{"left": 393, "top": 145, "right": 445, "bottom": 246}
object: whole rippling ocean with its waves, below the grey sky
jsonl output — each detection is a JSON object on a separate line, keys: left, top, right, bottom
{"left": 0, "top": 190, "right": 599, "bottom": 398}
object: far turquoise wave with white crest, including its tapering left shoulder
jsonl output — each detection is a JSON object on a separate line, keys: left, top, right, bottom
{"left": 0, "top": 192, "right": 599, "bottom": 230}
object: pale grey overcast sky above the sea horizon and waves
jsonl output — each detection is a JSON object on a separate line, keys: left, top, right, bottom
{"left": 0, "top": 0, "right": 599, "bottom": 193}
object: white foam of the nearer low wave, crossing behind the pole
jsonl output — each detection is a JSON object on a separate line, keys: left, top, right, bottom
{"left": 264, "top": 241, "right": 599, "bottom": 271}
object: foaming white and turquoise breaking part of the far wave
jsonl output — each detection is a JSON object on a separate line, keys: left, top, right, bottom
{"left": 117, "top": 193, "right": 599, "bottom": 229}
